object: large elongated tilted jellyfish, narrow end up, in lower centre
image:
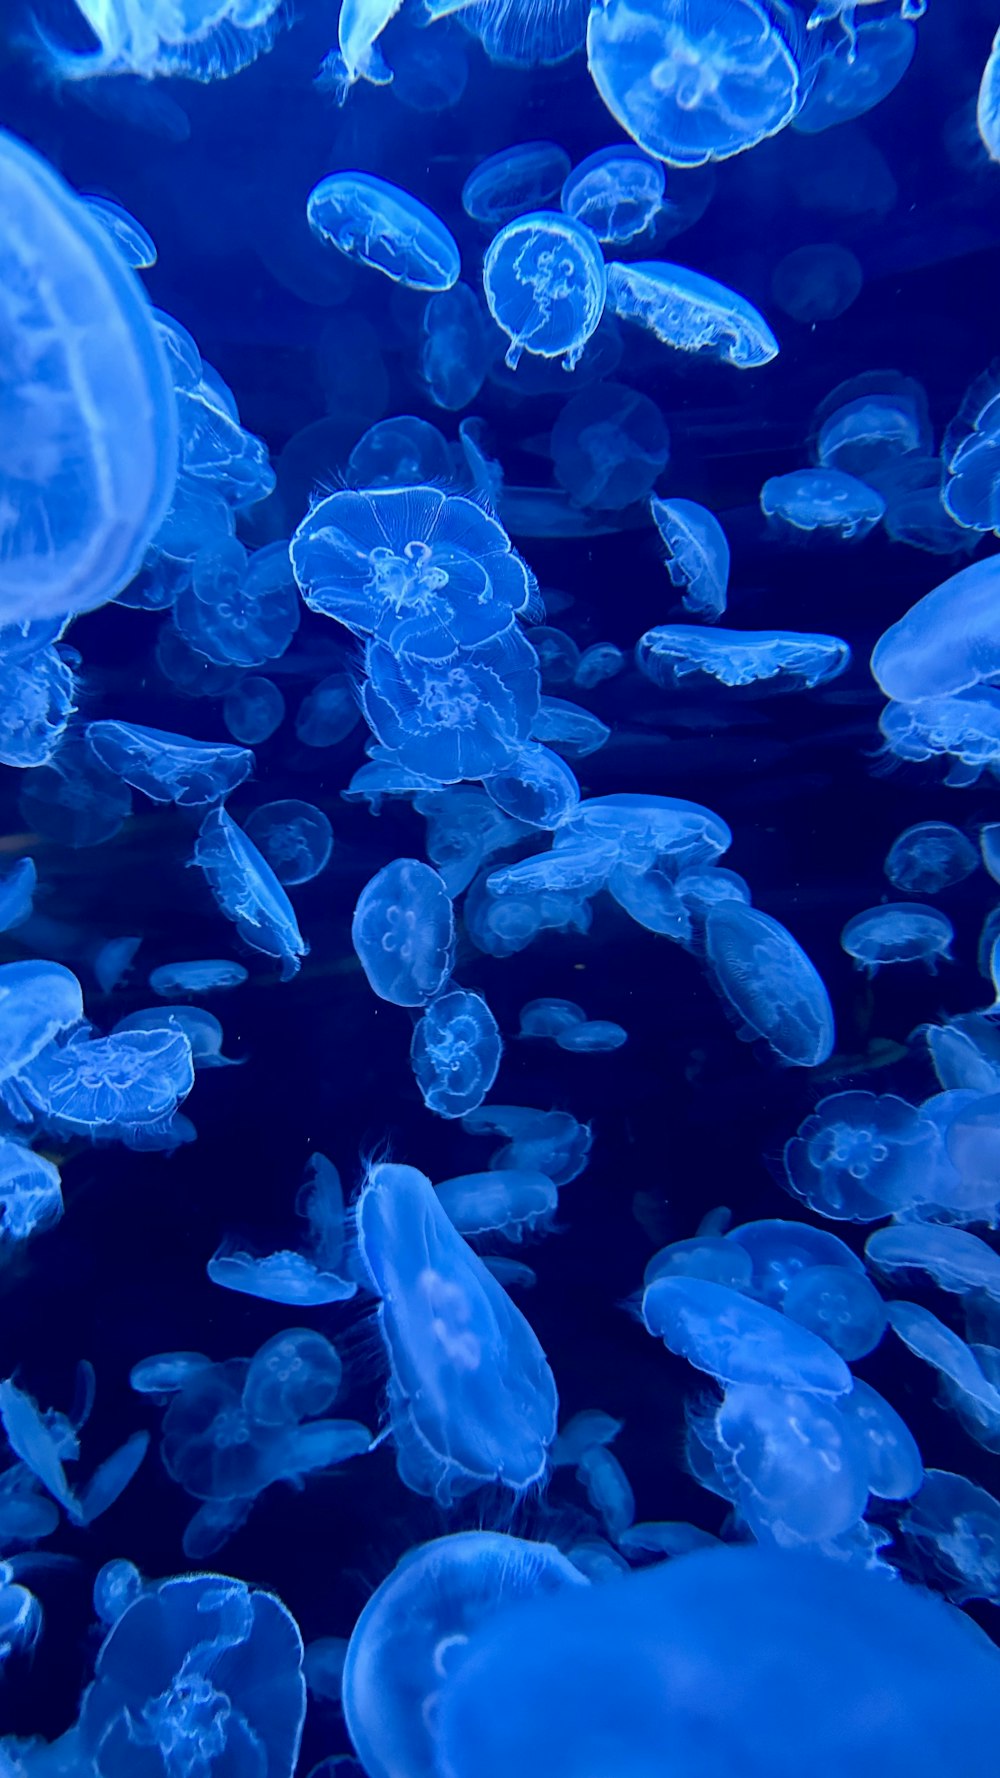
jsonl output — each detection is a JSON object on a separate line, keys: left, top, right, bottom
{"left": 356, "top": 1165, "right": 559, "bottom": 1506}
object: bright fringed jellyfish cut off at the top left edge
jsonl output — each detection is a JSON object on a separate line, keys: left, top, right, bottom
{"left": 39, "top": 0, "right": 286, "bottom": 82}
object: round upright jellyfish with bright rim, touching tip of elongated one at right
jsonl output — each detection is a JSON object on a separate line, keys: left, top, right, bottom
{"left": 482, "top": 210, "right": 607, "bottom": 370}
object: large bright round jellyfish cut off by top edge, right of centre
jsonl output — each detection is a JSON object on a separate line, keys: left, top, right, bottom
{"left": 587, "top": 0, "right": 799, "bottom": 167}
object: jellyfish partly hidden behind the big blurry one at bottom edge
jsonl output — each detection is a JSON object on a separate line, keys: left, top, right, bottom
{"left": 343, "top": 1531, "right": 587, "bottom": 1778}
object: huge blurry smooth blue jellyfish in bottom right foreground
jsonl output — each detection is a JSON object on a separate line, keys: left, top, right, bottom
{"left": 438, "top": 1547, "right": 1000, "bottom": 1778}
